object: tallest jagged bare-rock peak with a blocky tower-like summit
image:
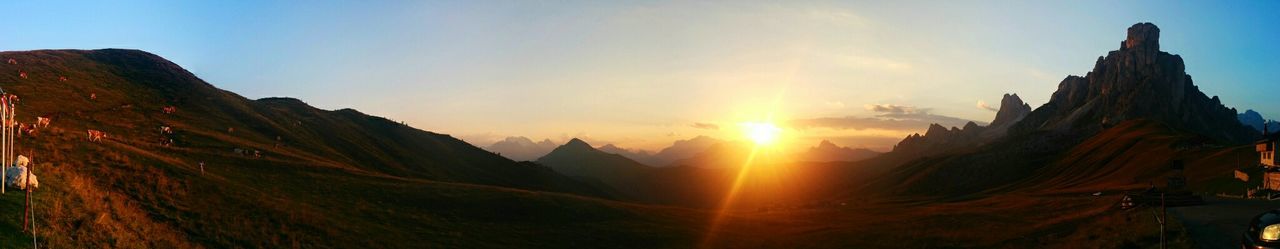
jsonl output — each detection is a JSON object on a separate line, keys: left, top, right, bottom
{"left": 1010, "top": 23, "right": 1257, "bottom": 143}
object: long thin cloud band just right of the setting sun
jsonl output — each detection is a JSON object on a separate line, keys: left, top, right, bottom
{"left": 787, "top": 105, "right": 984, "bottom": 130}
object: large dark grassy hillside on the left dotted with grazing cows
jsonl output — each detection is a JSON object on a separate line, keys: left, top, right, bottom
{"left": 0, "top": 50, "right": 619, "bottom": 248}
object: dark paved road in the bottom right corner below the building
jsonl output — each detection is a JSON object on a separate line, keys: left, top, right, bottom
{"left": 1169, "top": 197, "right": 1280, "bottom": 248}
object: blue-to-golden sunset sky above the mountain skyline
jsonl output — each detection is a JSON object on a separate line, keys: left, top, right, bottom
{"left": 0, "top": 0, "right": 1280, "bottom": 151}
